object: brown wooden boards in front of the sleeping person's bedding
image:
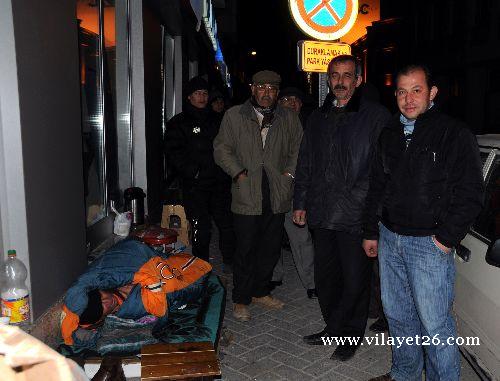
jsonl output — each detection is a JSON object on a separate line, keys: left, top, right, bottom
{"left": 141, "top": 342, "right": 221, "bottom": 381}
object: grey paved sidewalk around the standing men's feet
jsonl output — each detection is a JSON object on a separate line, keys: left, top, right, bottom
{"left": 210, "top": 236, "right": 480, "bottom": 381}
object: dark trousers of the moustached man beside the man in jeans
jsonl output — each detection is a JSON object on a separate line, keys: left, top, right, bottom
{"left": 313, "top": 229, "right": 372, "bottom": 337}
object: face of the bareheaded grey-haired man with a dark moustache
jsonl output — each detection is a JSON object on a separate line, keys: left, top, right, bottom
{"left": 328, "top": 61, "right": 361, "bottom": 106}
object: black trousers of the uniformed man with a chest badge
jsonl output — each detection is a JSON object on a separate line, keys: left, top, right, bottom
{"left": 182, "top": 186, "right": 236, "bottom": 264}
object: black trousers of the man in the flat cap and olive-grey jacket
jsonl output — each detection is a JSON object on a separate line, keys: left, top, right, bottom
{"left": 233, "top": 209, "right": 285, "bottom": 304}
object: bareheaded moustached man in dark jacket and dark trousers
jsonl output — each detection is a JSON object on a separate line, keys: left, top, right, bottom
{"left": 293, "top": 55, "right": 390, "bottom": 361}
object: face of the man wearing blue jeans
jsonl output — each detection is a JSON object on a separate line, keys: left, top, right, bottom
{"left": 396, "top": 69, "right": 438, "bottom": 119}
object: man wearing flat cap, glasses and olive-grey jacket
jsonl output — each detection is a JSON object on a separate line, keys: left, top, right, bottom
{"left": 214, "top": 70, "right": 302, "bottom": 321}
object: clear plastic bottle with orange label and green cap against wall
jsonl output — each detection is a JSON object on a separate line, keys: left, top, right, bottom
{"left": 0, "top": 250, "right": 30, "bottom": 325}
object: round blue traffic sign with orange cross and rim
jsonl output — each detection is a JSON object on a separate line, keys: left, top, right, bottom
{"left": 288, "top": 0, "right": 358, "bottom": 41}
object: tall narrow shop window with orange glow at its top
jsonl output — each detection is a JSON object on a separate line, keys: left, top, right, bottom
{"left": 76, "top": 0, "right": 131, "bottom": 239}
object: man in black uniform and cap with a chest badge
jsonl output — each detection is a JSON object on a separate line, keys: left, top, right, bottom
{"left": 165, "top": 77, "right": 236, "bottom": 265}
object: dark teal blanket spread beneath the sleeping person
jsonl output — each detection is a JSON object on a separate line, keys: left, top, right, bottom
{"left": 60, "top": 274, "right": 226, "bottom": 357}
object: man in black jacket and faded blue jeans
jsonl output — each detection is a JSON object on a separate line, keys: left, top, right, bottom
{"left": 363, "top": 65, "right": 483, "bottom": 381}
